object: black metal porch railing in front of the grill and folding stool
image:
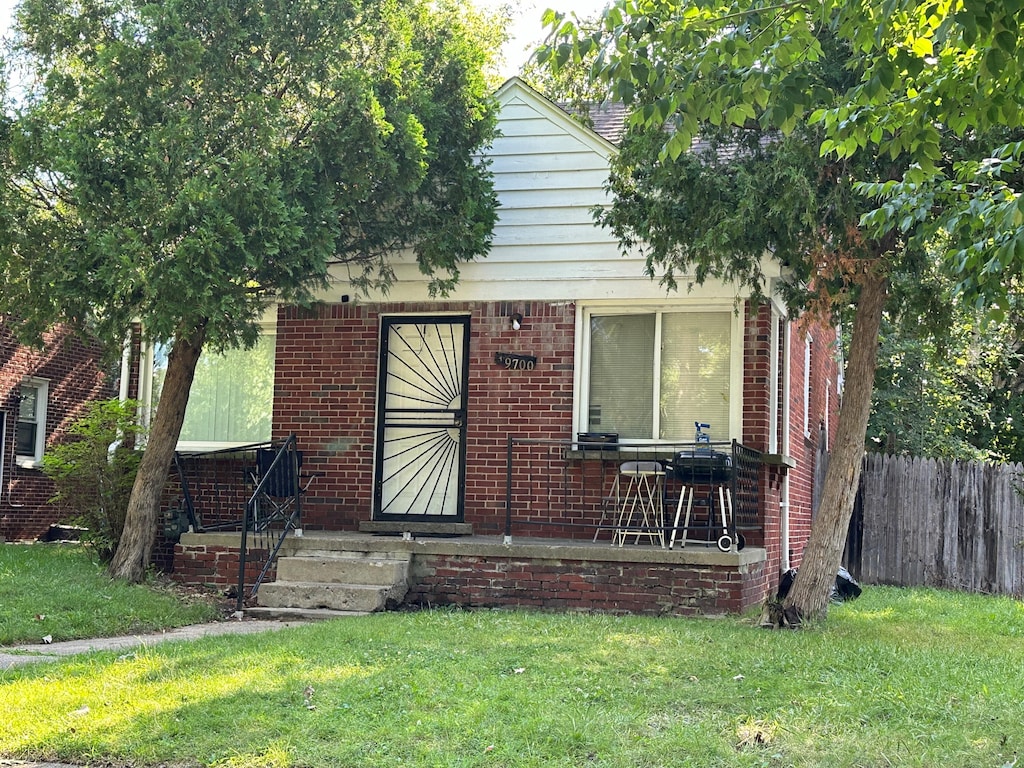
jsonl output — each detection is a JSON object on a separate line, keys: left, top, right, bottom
{"left": 505, "top": 435, "right": 764, "bottom": 550}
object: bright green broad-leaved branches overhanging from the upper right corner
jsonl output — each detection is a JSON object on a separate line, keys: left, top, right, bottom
{"left": 540, "top": 0, "right": 1024, "bottom": 312}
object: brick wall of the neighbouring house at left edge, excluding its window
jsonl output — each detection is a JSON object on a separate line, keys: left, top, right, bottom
{"left": 0, "top": 325, "right": 116, "bottom": 541}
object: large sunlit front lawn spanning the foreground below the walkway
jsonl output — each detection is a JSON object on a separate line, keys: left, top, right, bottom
{"left": 0, "top": 587, "right": 1024, "bottom": 768}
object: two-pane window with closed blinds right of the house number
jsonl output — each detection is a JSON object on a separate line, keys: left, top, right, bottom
{"left": 581, "top": 309, "right": 733, "bottom": 440}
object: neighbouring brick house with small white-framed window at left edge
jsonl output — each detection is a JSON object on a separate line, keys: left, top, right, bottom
{"left": 0, "top": 323, "right": 117, "bottom": 541}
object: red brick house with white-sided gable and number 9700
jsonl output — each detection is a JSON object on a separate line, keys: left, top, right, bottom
{"left": 167, "top": 79, "right": 841, "bottom": 613}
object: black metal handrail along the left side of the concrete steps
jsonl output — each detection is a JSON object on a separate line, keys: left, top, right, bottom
{"left": 236, "top": 433, "right": 302, "bottom": 610}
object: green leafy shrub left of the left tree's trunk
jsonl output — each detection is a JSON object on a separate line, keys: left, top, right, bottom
{"left": 43, "top": 399, "right": 144, "bottom": 562}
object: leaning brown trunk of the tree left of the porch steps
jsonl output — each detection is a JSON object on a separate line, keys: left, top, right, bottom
{"left": 110, "top": 326, "right": 206, "bottom": 582}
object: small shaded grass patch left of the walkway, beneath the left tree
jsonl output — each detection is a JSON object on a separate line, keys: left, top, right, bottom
{"left": 0, "top": 544, "right": 221, "bottom": 645}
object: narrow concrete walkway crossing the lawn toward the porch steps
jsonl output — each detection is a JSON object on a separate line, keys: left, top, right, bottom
{"left": 0, "top": 620, "right": 307, "bottom": 671}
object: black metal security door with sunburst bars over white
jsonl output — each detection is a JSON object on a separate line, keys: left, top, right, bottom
{"left": 374, "top": 316, "right": 469, "bottom": 522}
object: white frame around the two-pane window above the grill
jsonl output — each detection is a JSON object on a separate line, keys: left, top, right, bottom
{"left": 572, "top": 301, "right": 743, "bottom": 444}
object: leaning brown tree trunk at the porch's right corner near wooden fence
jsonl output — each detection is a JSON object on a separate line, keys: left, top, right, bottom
{"left": 783, "top": 273, "right": 889, "bottom": 625}
